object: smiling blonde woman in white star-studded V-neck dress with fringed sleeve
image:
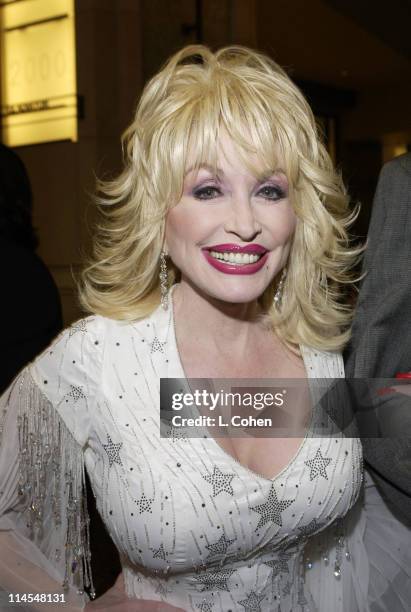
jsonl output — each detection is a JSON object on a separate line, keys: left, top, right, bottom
{"left": 0, "top": 46, "right": 409, "bottom": 612}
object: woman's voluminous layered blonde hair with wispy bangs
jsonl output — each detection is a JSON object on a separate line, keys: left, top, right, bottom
{"left": 80, "top": 45, "right": 358, "bottom": 350}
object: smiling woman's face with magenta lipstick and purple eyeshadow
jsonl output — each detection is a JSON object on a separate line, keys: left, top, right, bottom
{"left": 165, "top": 134, "right": 296, "bottom": 303}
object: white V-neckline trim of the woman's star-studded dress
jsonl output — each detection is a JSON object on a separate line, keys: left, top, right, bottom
{"left": 167, "top": 283, "right": 314, "bottom": 484}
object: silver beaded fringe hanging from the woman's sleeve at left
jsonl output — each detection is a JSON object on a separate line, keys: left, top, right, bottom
{"left": 17, "top": 370, "right": 95, "bottom": 599}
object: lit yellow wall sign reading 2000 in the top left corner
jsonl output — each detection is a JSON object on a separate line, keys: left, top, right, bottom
{"left": 0, "top": 0, "right": 78, "bottom": 147}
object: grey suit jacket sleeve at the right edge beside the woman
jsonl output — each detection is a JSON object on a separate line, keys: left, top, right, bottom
{"left": 346, "top": 155, "right": 411, "bottom": 520}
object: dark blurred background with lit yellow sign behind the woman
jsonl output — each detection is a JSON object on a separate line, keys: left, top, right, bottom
{"left": 0, "top": 0, "right": 411, "bottom": 325}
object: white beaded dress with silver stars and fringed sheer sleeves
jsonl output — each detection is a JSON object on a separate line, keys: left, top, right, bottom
{"left": 0, "top": 284, "right": 411, "bottom": 612}
